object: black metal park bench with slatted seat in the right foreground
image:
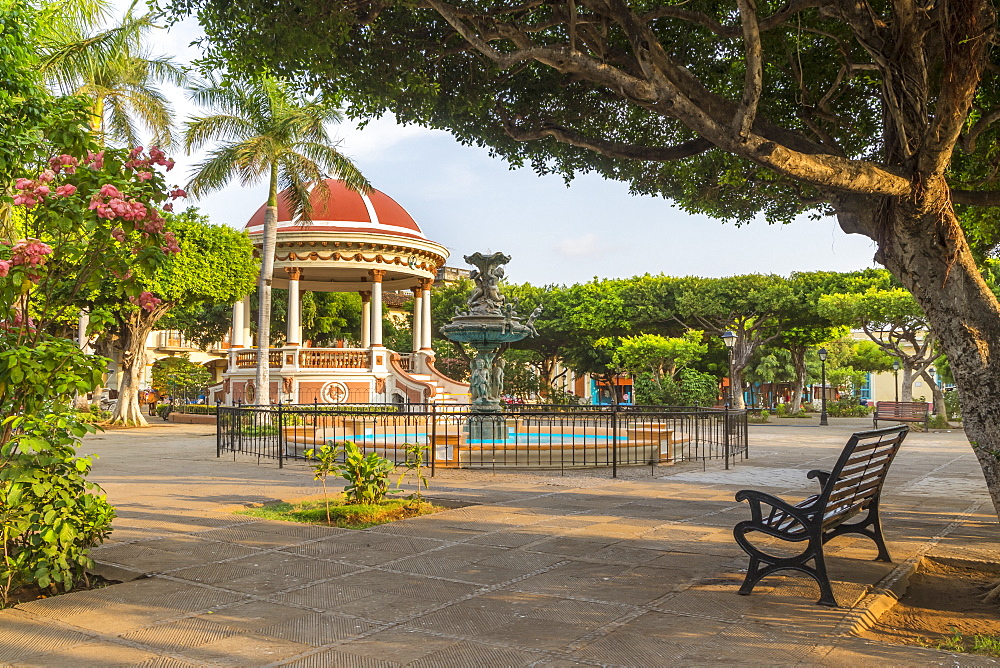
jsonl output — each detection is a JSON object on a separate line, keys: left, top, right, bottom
{"left": 733, "top": 425, "right": 910, "bottom": 607}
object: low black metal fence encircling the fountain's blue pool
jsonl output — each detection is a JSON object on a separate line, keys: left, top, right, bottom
{"left": 217, "top": 404, "right": 749, "bottom": 476}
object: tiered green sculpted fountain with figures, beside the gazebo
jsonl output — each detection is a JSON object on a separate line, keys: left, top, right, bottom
{"left": 441, "top": 253, "right": 541, "bottom": 440}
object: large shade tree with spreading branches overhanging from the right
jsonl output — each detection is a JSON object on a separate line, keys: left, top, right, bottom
{"left": 172, "top": 0, "right": 1000, "bottom": 511}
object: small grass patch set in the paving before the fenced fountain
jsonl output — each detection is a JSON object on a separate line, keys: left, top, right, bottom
{"left": 236, "top": 499, "right": 447, "bottom": 529}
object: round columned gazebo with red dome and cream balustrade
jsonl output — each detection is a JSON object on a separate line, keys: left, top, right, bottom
{"left": 219, "top": 179, "right": 468, "bottom": 403}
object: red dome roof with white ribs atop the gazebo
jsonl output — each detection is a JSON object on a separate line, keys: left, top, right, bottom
{"left": 246, "top": 179, "right": 426, "bottom": 239}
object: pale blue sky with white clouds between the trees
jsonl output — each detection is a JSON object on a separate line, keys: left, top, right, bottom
{"left": 137, "top": 3, "right": 875, "bottom": 285}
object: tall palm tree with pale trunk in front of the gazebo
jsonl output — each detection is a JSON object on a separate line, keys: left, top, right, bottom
{"left": 184, "top": 76, "right": 371, "bottom": 401}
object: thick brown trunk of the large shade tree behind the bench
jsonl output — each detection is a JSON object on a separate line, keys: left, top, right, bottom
{"left": 878, "top": 183, "right": 1000, "bottom": 514}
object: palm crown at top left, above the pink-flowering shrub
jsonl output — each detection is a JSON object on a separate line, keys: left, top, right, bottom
{"left": 40, "top": 2, "right": 187, "bottom": 146}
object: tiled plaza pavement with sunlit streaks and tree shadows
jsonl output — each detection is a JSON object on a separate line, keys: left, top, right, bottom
{"left": 0, "top": 420, "right": 1000, "bottom": 668}
